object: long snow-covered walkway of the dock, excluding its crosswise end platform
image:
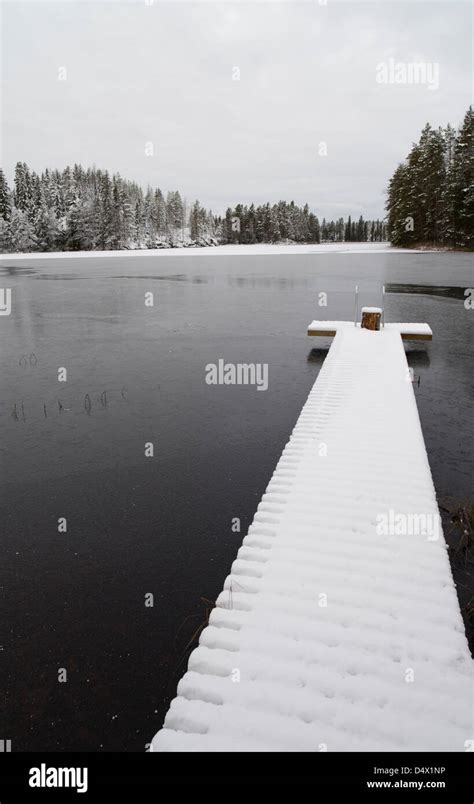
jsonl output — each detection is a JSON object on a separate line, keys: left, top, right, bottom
{"left": 151, "top": 325, "right": 474, "bottom": 751}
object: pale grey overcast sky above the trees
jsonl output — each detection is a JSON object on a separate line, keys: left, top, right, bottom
{"left": 1, "top": 0, "right": 473, "bottom": 217}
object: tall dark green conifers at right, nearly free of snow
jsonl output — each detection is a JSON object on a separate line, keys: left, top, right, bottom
{"left": 386, "top": 106, "right": 474, "bottom": 249}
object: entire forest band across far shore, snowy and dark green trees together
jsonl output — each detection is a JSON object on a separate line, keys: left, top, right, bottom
{"left": 0, "top": 107, "right": 468, "bottom": 252}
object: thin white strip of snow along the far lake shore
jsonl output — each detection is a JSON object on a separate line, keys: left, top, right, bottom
{"left": 0, "top": 243, "right": 444, "bottom": 260}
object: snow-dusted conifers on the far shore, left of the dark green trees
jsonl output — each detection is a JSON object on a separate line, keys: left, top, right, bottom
{"left": 0, "top": 162, "right": 386, "bottom": 252}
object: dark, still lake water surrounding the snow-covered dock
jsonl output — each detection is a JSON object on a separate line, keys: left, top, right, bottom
{"left": 0, "top": 248, "right": 474, "bottom": 751}
